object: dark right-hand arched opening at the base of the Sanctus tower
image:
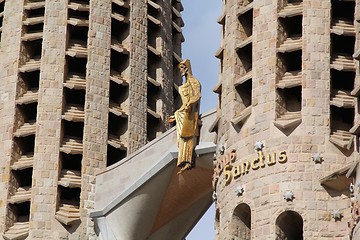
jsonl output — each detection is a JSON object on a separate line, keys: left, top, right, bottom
{"left": 276, "top": 211, "right": 304, "bottom": 240}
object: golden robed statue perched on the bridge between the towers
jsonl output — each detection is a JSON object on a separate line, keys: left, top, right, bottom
{"left": 167, "top": 59, "right": 201, "bottom": 174}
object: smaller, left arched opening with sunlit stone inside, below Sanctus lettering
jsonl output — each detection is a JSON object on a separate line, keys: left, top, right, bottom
{"left": 230, "top": 203, "right": 251, "bottom": 240}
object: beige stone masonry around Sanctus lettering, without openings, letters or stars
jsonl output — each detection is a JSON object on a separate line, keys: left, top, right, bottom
{"left": 216, "top": 0, "right": 358, "bottom": 240}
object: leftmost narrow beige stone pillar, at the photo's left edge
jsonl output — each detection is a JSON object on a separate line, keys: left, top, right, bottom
{"left": 0, "top": 0, "right": 23, "bottom": 232}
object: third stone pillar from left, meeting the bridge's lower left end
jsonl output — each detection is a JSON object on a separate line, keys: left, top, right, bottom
{"left": 80, "top": 0, "right": 111, "bottom": 239}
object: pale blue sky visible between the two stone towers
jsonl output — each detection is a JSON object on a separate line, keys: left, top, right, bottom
{"left": 182, "top": 0, "right": 222, "bottom": 240}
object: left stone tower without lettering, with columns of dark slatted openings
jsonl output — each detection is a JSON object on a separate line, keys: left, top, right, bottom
{"left": 0, "top": 0, "right": 184, "bottom": 239}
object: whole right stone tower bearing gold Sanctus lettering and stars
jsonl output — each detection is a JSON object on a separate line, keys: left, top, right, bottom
{"left": 212, "top": 0, "right": 360, "bottom": 240}
